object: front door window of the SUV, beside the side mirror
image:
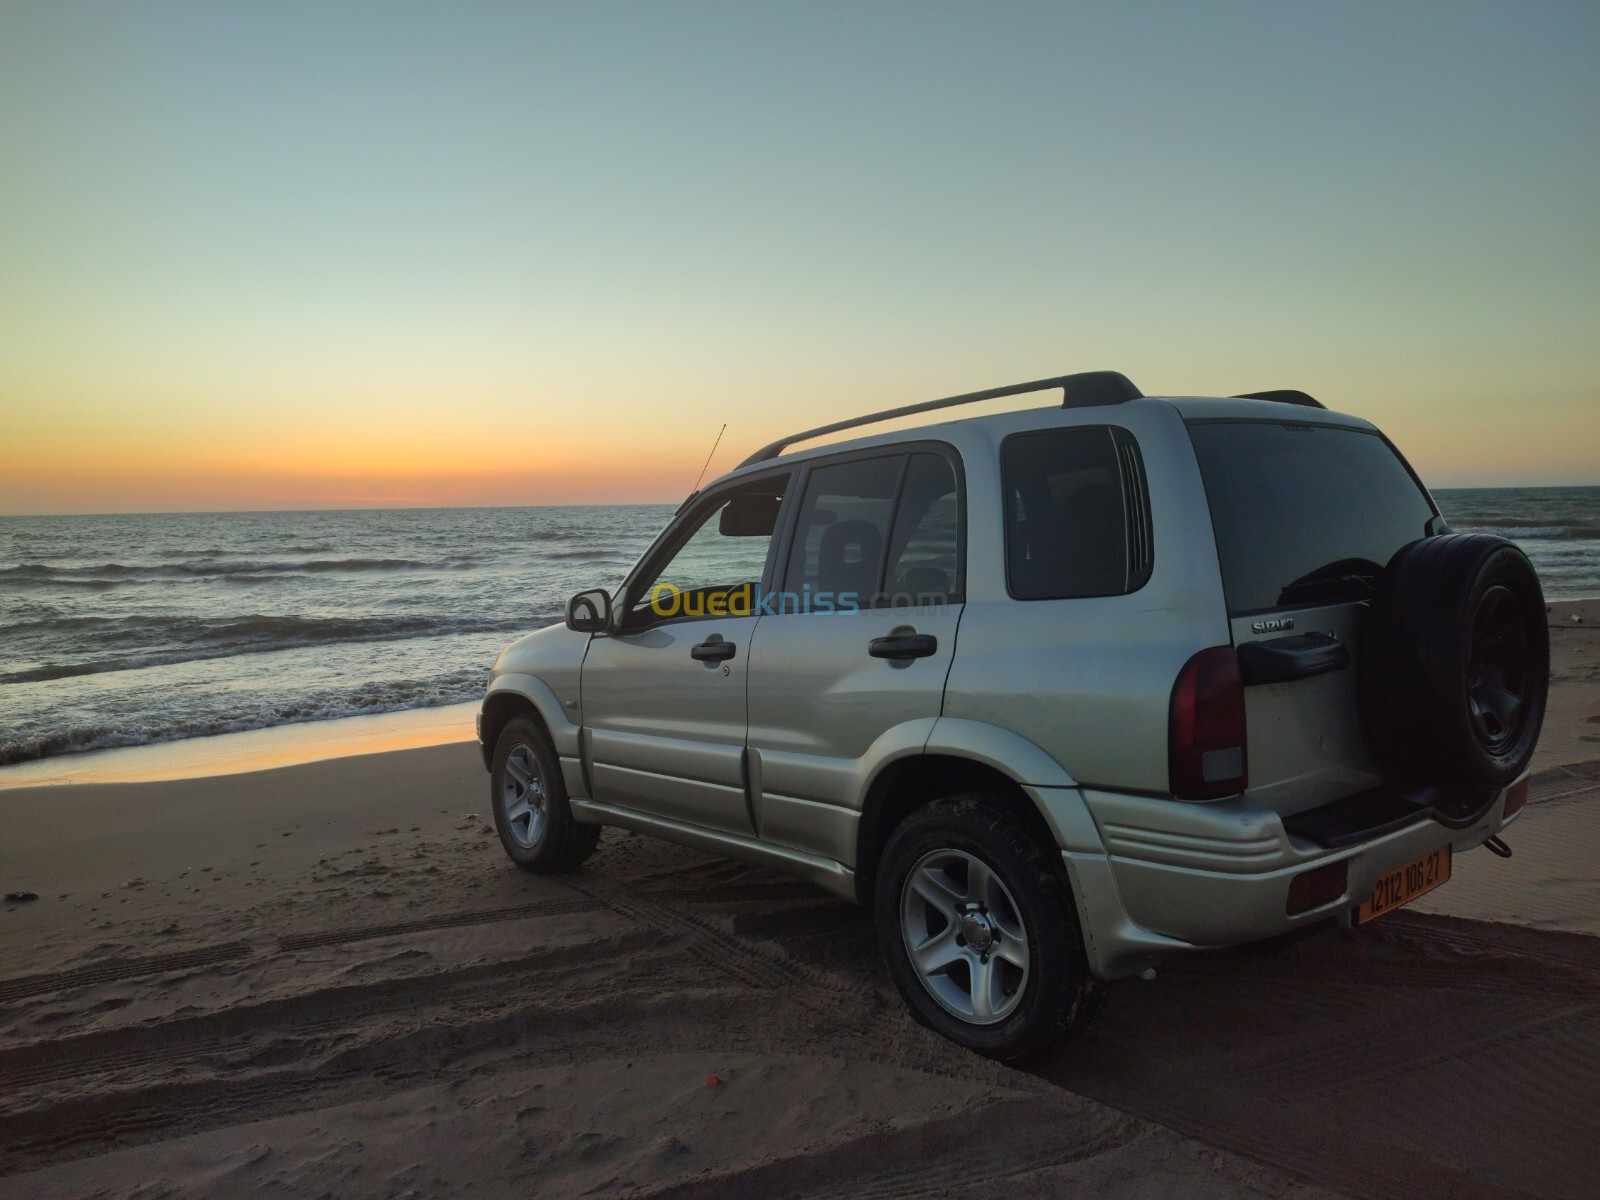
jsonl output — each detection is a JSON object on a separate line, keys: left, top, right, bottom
{"left": 627, "top": 475, "right": 789, "bottom": 624}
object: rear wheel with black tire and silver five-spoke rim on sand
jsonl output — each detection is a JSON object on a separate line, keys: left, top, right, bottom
{"left": 874, "top": 792, "right": 1106, "bottom": 1062}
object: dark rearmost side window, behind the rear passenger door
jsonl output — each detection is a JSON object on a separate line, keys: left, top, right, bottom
{"left": 1000, "top": 426, "right": 1152, "bottom": 600}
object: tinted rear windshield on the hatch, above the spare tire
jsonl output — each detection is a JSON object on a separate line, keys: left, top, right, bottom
{"left": 1189, "top": 421, "right": 1434, "bottom": 616}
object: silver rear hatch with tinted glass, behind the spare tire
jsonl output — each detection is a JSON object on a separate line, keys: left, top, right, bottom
{"left": 1189, "top": 413, "right": 1437, "bottom": 816}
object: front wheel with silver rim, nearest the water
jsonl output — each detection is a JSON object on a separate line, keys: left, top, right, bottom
{"left": 490, "top": 717, "right": 600, "bottom": 875}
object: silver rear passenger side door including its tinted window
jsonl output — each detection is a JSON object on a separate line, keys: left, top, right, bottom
{"left": 749, "top": 443, "right": 965, "bottom": 862}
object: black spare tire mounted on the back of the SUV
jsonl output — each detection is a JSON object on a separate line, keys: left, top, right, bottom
{"left": 1360, "top": 533, "right": 1550, "bottom": 824}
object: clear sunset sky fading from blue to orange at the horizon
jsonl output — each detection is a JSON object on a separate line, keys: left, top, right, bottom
{"left": 0, "top": 0, "right": 1600, "bottom": 514}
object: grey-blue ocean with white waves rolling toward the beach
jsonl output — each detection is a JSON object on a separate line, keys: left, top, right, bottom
{"left": 0, "top": 488, "right": 1600, "bottom": 765}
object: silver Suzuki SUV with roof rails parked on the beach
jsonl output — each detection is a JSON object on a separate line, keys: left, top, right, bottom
{"left": 478, "top": 371, "right": 1549, "bottom": 1061}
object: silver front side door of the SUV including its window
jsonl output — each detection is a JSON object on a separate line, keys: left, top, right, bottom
{"left": 582, "top": 474, "right": 787, "bottom": 834}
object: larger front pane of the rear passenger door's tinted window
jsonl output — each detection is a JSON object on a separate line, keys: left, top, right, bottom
{"left": 786, "top": 454, "right": 906, "bottom": 605}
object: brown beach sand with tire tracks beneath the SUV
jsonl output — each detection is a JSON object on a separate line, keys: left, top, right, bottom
{"left": 0, "top": 605, "right": 1600, "bottom": 1198}
